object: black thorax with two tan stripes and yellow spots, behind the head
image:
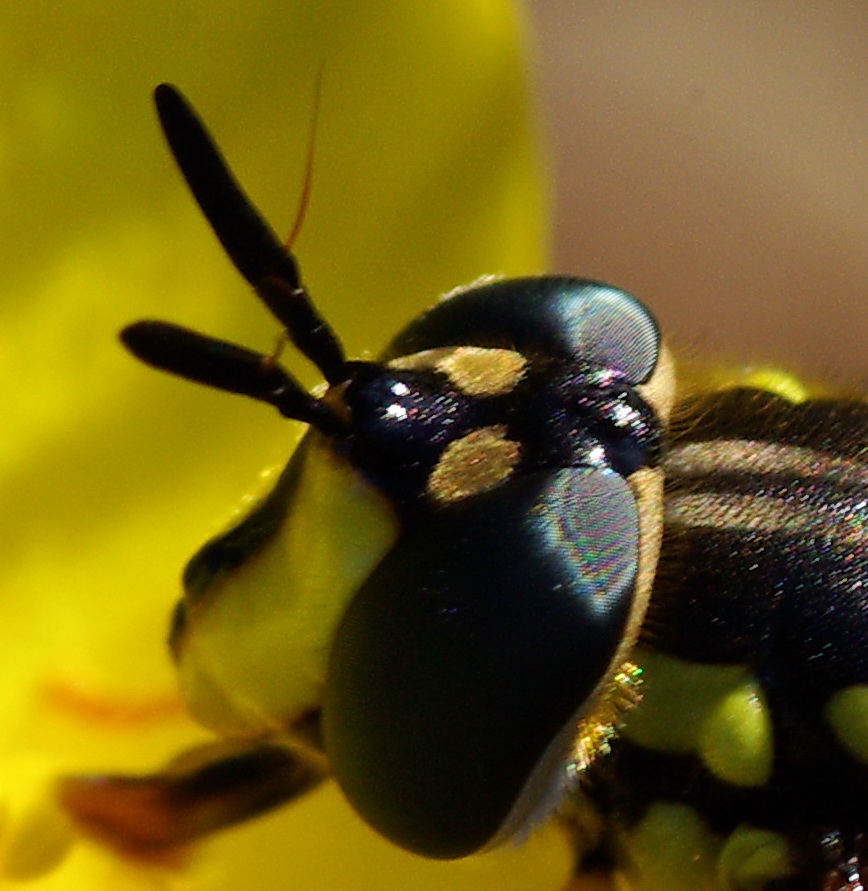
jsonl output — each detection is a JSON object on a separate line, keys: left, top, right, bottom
{"left": 576, "top": 387, "right": 868, "bottom": 891}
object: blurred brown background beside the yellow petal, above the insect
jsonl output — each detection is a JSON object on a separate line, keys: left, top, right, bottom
{"left": 531, "top": 0, "right": 868, "bottom": 387}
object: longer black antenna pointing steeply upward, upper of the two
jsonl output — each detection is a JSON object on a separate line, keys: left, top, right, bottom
{"left": 154, "top": 84, "right": 346, "bottom": 384}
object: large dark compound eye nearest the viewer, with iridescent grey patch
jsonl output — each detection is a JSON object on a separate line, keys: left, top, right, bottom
{"left": 323, "top": 467, "right": 639, "bottom": 859}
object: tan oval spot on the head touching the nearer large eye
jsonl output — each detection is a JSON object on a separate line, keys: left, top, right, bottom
{"left": 427, "top": 424, "right": 521, "bottom": 504}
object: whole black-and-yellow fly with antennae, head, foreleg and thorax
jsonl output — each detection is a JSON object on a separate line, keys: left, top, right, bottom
{"left": 61, "top": 85, "right": 868, "bottom": 891}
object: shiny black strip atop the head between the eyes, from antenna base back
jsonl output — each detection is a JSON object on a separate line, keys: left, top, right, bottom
{"left": 335, "top": 342, "right": 662, "bottom": 512}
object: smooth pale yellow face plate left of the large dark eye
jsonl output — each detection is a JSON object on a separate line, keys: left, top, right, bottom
{"left": 178, "top": 432, "right": 399, "bottom": 738}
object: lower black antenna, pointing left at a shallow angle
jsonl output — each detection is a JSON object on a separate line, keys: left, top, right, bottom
{"left": 121, "top": 321, "right": 344, "bottom": 433}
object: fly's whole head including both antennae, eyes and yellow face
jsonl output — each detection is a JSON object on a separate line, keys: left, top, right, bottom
{"left": 118, "top": 87, "right": 671, "bottom": 858}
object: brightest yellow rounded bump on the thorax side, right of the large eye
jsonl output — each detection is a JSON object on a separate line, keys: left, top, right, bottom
{"left": 699, "top": 680, "right": 774, "bottom": 786}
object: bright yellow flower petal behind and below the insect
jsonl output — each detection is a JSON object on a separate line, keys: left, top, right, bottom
{"left": 0, "top": 0, "right": 566, "bottom": 891}
